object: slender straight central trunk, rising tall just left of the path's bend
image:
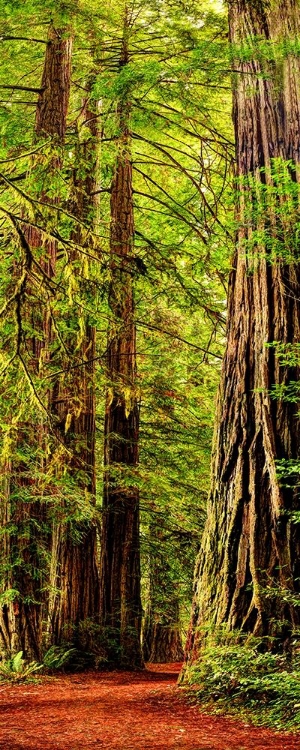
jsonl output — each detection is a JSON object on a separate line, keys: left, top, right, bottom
{"left": 100, "top": 15, "right": 142, "bottom": 668}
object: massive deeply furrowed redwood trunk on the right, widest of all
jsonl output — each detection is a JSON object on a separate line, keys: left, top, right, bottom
{"left": 187, "top": 0, "right": 300, "bottom": 660}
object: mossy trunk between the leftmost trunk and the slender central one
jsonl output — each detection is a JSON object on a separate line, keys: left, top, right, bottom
{"left": 49, "top": 92, "right": 99, "bottom": 648}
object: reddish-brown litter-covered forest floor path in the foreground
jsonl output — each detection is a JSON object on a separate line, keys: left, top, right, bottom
{"left": 0, "top": 664, "right": 300, "bottom": 750}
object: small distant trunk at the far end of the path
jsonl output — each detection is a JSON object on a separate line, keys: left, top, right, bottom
{"left": 143, "top": 525, "right": 183, "bottom": 664}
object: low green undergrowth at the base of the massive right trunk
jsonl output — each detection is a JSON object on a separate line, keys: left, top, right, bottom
{"left": 185, "top": 632, "right": 300, "bottom": 731}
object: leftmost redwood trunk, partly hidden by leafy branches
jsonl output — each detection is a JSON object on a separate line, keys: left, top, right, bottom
{"left": 0, "top": 26, "right": 72, "bottom": 658}
